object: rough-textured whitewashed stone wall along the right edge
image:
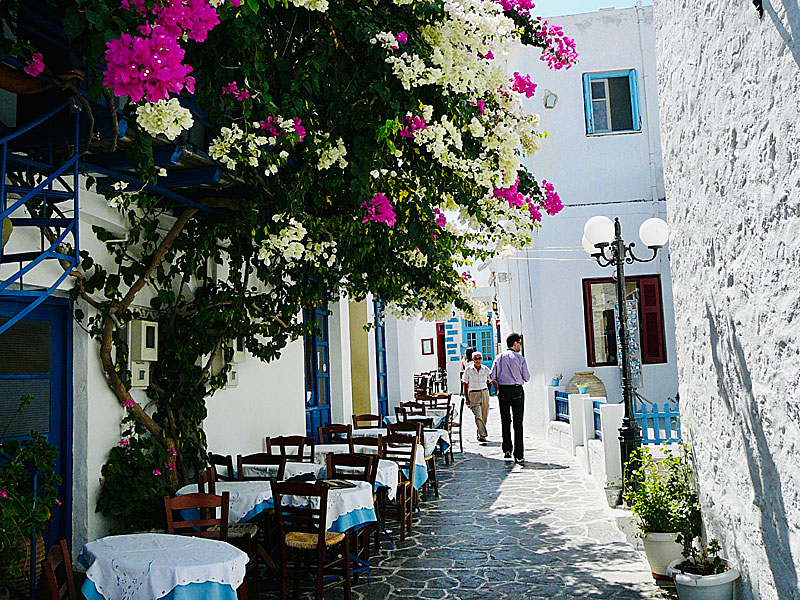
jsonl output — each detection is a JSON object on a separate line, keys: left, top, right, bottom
{"left": 655, "top": 0, "right": 800, "bottom": 600}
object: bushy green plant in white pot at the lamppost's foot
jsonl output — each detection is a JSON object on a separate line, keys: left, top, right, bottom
{"left": 625, "top": 445, "right": 701, "bottom": 580}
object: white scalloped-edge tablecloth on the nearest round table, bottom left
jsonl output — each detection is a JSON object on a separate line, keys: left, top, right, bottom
{"left": 78, "top": 533, "right": 247, "bottom": 600}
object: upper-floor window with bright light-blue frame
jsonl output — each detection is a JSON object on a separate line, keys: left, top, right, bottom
{"left": 583, "top": 69, "right": 642, "bottom": 134}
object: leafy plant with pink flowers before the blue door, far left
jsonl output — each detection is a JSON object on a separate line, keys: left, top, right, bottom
{"left": 0, "top": 431, "right": 61, "bottom": 597}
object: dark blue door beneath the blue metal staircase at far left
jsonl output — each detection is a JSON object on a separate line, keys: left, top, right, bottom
{"left": 0, "top": 296, "right": 72, "bottom": 546}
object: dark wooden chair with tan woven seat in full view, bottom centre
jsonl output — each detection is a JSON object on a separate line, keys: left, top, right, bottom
{"left": 270, "top": 479, "right": 351, "bottom": 600}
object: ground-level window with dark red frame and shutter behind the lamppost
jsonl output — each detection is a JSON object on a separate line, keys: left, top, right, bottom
{"left": 583, "top": 275, "right": 667, "bottom": 367}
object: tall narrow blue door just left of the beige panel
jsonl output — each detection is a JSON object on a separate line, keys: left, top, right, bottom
{"left": 304, "top": 305, "right": 331, "bottom": 441}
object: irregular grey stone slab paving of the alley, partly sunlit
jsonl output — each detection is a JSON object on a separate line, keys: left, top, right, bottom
{"left": 263, "top": 399, "right": 674, "bottom": 600}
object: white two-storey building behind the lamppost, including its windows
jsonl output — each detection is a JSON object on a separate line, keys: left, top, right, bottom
{"left": 493, "top": 6, "right": 677, "bottom": 433}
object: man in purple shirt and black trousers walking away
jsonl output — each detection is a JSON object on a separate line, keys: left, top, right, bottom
{"left": 491, "top": 333, "right": 531, "bottom": 465}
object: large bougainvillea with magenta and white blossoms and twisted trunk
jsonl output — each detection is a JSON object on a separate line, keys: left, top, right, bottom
{"left": 0, "top": 0, "right": 577, "bottom": 522}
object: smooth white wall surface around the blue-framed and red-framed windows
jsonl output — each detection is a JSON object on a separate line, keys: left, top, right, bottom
{"left": 493, "top": 7, "right": 677, "bottom": 435}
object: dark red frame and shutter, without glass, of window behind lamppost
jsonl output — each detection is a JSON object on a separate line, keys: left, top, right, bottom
{"left": 582, "top": 275, "right": 667, "bottom": 367}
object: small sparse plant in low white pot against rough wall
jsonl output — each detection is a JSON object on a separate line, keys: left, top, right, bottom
{"left": 667, "top": 531, "right": 740, "bottom": 600}
